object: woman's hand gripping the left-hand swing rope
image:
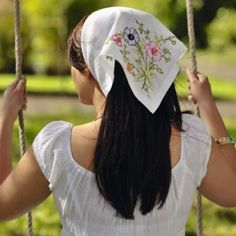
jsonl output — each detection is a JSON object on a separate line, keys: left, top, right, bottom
{"left": 1, "top": 79, "right": 27, "bottom": 123}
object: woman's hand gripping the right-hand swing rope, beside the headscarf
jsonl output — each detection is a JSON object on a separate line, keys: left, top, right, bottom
{"left": 186, "top": 69, "right": 213, "bottom": 105}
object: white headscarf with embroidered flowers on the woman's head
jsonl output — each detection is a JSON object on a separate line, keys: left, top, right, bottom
{"left": 80, "top": 7, "right": 186, "bottom": 113}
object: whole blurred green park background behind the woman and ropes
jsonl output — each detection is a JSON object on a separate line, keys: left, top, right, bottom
{"left": 0, "top": 0, "right": 236, "bottom": 236}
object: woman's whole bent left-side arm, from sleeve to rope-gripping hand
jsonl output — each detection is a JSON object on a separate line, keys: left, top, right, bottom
{"left": 0, "top": 80, "right": 50, "bottom": 220}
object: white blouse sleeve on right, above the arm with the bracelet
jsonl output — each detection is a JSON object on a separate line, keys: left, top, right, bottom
{"left": 184, "top": 115, "right": 212, "bottom": 187}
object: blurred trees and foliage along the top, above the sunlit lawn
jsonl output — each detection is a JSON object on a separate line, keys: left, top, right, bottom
{"left": 0, "top": 0, "right": 235, "bottom": 74}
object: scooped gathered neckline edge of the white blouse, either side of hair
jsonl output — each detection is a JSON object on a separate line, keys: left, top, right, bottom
{"left": 67, "top": 121, "right": 184, "bottom": 177}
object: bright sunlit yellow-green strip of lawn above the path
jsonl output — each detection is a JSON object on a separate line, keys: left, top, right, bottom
{"left": 0, "top": 74, "right": 236, "bottom": 100}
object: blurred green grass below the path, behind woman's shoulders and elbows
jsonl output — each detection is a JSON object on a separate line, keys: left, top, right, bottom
{"left": 0, "top": 113, "right": 236, "bottom": 236}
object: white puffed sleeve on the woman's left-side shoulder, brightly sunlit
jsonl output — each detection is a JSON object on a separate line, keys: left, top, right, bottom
{"left": 32, "top": 121, "right": 71, "bottom": 191}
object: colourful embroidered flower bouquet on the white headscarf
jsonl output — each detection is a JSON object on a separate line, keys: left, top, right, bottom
{"left": 105, "top": 20, "right": 176, "bottom": 94}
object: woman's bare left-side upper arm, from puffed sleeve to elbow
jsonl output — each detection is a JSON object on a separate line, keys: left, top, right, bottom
{"left": 0, "top": 148, "right": 51, "bottom": 221}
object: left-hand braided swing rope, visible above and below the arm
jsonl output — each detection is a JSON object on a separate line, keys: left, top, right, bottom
{"left": 14, "top": 0, "right": 33, "bottom": 236}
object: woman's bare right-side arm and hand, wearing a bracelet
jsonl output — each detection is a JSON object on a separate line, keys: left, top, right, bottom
{"left": 187, "top": 70, "right": 236, "bottom": 206}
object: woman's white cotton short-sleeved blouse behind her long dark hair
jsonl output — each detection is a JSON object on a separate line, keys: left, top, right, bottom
{"left": 33, "top": 115, "right": 211, "bottom": 236}
